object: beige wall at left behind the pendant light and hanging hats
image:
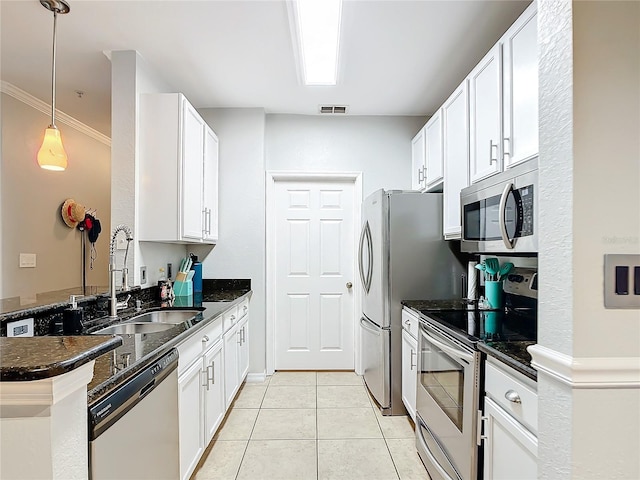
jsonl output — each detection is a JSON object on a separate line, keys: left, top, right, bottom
{"left": 0, "top": 87, "right": 111, "bottom": 296}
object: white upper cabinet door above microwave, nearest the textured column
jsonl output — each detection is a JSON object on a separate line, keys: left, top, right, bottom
{"left": 502, "top": 5, "right": 538, "bottom": 168}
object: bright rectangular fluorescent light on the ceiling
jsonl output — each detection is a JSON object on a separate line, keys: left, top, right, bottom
{"left": 295, "top": 0, "right": 342, "bottom": 85}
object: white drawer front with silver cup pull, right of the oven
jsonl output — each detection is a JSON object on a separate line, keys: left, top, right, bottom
{"left": 485, "top": 361, "right": 538, "bottom": 435}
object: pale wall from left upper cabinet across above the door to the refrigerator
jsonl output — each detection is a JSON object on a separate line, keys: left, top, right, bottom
{"left": 196, "top": 109, "right": 426, "bottom": 374}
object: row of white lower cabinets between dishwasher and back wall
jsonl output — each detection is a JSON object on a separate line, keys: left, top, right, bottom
{"left": 177, "top": 300, "right": 249, "bottom": 480}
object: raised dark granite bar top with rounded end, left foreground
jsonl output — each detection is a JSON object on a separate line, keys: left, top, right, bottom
{"left": 0, "top": 335, "right": 122, "bottom": 381}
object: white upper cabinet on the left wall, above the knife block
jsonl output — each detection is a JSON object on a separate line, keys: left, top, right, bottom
{"left": 139, "top": 93, "right": 218, "bottom": 243}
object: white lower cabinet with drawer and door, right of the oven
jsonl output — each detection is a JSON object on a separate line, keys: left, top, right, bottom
{"left": 483, "top": 362, "right": 538, "bottom": 480}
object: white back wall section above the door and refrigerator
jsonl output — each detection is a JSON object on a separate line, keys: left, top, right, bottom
{"left": 266, "top": 115, "right": 426, "bottom": 197}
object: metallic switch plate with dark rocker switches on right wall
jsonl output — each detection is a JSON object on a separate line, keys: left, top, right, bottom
{"left": 604, "top": 253, "right": 640, "bottom": 309}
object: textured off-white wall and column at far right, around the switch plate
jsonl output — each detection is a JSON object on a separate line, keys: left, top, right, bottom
{"left": 534, "top": 0, "right": 640, "bottom": 479}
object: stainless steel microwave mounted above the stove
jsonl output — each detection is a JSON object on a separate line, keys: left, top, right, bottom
{"left": 460, "top": 158, "right": 539, "bottom": 254}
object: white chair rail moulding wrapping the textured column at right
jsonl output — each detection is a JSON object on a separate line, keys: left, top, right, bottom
{"left": 527, "top": 345, "right": 640, "bottom": 389}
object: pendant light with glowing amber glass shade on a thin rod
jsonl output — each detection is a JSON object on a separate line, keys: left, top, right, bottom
{"left": 38, "top": 0, "right": 70, "bottom": 171}
